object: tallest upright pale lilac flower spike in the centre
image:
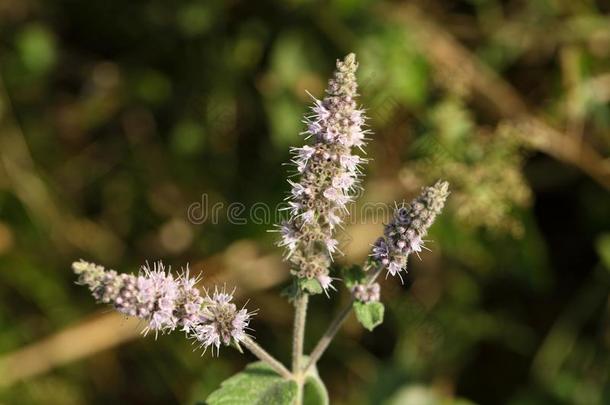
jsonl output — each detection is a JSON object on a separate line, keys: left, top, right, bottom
{"left": 278, "top": 53, "right": 368, "bottom": 292}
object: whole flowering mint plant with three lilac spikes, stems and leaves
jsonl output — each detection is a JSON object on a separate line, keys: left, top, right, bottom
{"left": 72, "top": 54, "right": 449, "bottom": 405}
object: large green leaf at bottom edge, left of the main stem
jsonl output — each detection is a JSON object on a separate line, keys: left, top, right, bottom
{"left": 206, "top": 361, "right": 297, "bottom": 405}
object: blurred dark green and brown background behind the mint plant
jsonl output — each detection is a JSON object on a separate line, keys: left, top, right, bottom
{"left": 0, "top": 0, "right": 610, "bottom": 405}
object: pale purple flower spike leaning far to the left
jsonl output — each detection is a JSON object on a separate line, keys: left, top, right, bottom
{"left": 72, "top": 260, "right": 252, "bottom": 351}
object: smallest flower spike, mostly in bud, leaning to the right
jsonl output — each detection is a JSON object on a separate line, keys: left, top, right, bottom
{"left": 371, "top": 181, "right": 449, "bottom": 277}
